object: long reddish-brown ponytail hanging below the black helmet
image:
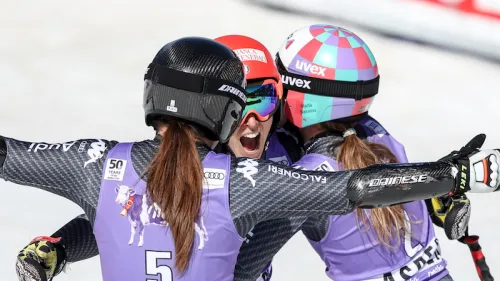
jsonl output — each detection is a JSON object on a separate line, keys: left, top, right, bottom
{"left": 147, "top": 117, "right": 203, "bottom": 272}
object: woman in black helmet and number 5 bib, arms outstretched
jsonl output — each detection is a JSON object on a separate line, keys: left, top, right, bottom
{"left": 4, "top": 38, "right": 498, "bottom": 281}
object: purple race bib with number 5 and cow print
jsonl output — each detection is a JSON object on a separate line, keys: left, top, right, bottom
{"left": 94, "top": 143, "right": 243, "bottom": 281}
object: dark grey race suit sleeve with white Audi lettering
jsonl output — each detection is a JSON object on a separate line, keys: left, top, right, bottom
{"left": 0, "top": 137, "right": 117, "bottom": 222}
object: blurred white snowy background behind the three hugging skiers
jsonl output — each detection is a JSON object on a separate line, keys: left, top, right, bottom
{"left": 0, "top": 0, "right": 500, "bottom": 281}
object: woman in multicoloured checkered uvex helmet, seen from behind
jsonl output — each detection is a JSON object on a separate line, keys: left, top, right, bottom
{"left": 276, "top": 25, "right": 460, "bottom": 281}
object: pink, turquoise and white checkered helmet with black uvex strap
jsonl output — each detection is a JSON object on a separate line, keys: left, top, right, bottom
{"left": 276, "top": 25, "right": 379, "bottom": 128}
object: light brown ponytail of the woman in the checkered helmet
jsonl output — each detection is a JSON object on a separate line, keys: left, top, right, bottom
{"left": 322, "top": 121, "right": 410, "bottom": 248}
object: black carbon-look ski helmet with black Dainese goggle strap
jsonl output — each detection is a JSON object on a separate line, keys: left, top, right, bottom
{"left": 143, "top": 37, "right": 246, "bottom": 142}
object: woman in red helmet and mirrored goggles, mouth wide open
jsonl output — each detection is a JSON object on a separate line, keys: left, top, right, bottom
{"left": 17, "top": 35, "right": 300, "bottom": 280}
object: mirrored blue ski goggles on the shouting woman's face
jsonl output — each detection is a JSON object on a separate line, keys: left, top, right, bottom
{"left": 241, "top": 80, "right": 279, "bottom": 123}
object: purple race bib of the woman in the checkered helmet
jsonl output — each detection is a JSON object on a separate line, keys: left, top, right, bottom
{"left": 295, "top": 117, "right": 448, "bottom": 281}
